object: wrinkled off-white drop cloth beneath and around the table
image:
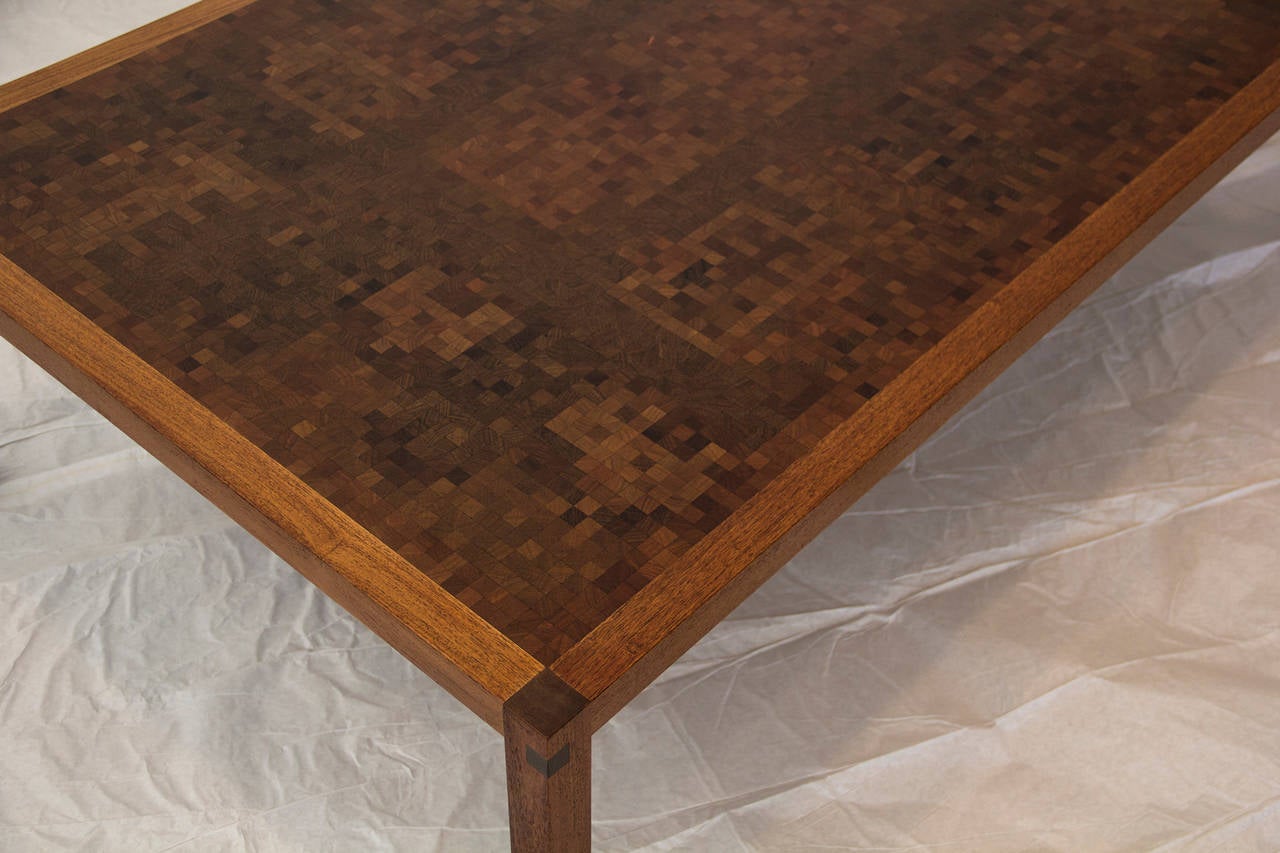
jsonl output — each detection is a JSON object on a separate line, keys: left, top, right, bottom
{"left": 0, "top": 0, "right": 1280, "bottom": 852}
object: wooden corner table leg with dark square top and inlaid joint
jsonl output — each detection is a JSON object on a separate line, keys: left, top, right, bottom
{"left": 503, "top": 670, "right": 591, "bottom": 853}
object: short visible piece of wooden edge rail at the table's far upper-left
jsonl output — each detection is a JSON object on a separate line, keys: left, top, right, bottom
{"left": 0, "top": 0, "right": 253, "bottom": 113}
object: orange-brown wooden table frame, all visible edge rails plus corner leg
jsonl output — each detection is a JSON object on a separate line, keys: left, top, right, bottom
{"left": 0, "top": 0, "right": 1280, "bottom": 853}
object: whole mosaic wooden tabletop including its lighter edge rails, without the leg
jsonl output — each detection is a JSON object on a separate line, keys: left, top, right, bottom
{"left": 0, "top": 0, "right": 1280, "bottom": 722}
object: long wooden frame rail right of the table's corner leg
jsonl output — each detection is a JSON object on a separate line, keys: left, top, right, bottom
{"left": 550, "top": 61, "right": 1280, "bottom": 712}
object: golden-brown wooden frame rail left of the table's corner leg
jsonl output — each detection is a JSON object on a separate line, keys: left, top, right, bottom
{"left": 0, "top": 256, "right": 543, "bottom": 730}
